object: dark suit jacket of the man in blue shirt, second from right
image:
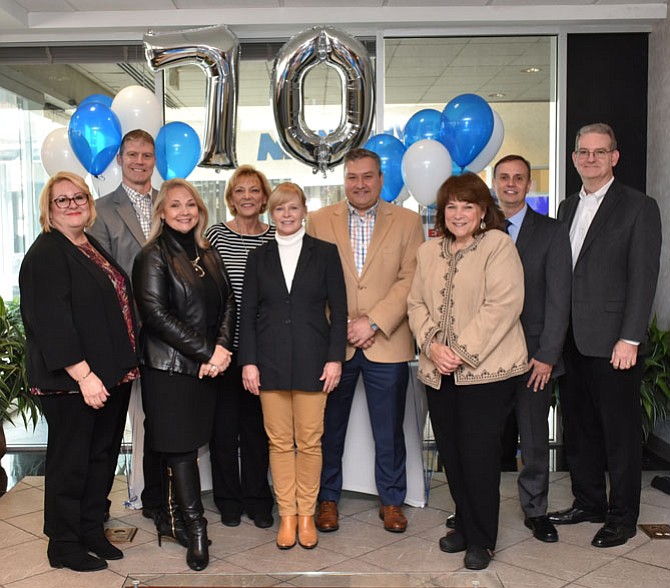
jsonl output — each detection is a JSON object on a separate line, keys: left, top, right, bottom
{"left": 516, "top": 206, "right": 572, "bottom": 377}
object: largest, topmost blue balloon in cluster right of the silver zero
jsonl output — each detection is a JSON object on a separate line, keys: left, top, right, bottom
{"left": 440, "top": 94, "right": 494, "bottom": 167}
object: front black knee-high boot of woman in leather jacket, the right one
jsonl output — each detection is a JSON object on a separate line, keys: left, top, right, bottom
{"left": 170, "top": 460, "right": 209, "bottom": 571}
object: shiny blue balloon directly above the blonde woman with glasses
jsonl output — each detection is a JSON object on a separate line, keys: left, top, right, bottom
{"left": 67, "top": 102, "right": 122, "bottom": 176}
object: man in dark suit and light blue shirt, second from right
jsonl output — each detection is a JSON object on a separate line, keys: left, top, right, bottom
{"left": 493, "top": 155, "right": 572, "bottom": 543}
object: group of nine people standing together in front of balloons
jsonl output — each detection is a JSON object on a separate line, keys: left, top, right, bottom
{"left": 19, "top": 124, "right": 661, "bottom": 571}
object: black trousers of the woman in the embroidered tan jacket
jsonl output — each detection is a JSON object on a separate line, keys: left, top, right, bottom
{"left": 426, "top": 376, "right": 516, "bottom": 550}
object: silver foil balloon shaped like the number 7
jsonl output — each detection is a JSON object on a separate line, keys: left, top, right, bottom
{"left": 144, "top": 26, "right": 240, "bottom": 169}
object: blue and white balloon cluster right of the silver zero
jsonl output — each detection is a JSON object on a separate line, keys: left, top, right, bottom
{"left": 365, "top": 94, "right": 505, "bottom": 206}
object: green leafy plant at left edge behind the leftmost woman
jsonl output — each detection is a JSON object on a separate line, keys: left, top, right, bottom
{"left": 0, "top": 296, "right": 40, "bottom": 457}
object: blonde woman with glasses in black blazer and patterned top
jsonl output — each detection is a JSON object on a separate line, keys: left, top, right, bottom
{"left": 19, "top": 172, "right": 139, "bottom": 572}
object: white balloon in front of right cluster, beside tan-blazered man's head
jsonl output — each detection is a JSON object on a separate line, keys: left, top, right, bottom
{"left": 402, "top": 139, "right": 452, "bottom": 206}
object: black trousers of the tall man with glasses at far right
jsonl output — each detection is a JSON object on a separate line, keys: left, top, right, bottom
{"left": 559, "top": 332, "right": 644, "bottom": 527}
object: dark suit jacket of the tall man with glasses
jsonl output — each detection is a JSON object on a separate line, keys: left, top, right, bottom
{"left": 558, "top": 179, "right": 661, "bottom": 358}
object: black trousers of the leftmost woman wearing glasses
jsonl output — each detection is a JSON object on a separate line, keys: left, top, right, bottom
{"left": 40, "top": 383, "right": 131, "bottom": 543}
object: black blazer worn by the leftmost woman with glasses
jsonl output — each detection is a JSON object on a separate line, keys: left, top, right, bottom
{"left": 19, "top": 229, "right": 137, "bottom": 391}
